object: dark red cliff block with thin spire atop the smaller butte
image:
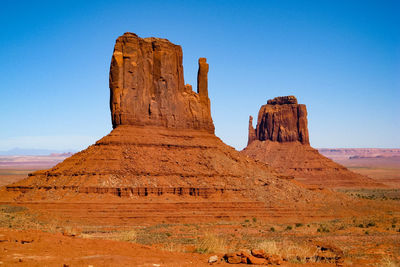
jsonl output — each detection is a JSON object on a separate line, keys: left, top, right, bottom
{"left": 248, "top": 96, "right": 310, "bottom": 144}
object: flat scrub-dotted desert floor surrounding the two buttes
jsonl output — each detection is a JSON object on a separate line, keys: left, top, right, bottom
{"left": 0, "top": 154, "right": 400, "bottom": 266}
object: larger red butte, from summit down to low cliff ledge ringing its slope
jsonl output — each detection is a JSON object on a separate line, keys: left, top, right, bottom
{"left": 3, "top": 33, "right": 310, "bottom": 205}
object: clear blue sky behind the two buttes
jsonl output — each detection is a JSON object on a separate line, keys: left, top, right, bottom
{"left": 0, "top": 0, "right": 400, "bottom": 150}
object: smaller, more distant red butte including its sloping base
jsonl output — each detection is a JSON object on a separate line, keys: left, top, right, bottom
{"left": 242, "top": 96, "right": 383, "bottom": 188}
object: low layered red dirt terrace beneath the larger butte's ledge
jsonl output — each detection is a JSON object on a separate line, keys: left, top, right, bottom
{"left": 0, "top": 200, "right": 376, "bottom": 226}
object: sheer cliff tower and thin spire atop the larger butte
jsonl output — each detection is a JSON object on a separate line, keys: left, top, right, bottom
{"left": 110, "top": 33, "right": 214, "bottom": 133}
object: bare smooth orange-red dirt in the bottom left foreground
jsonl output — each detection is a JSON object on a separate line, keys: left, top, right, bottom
{"left": 0, "top": 228, "right": 208, "bottom": 266}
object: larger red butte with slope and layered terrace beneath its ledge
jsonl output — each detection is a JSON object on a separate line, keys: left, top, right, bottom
{"left": 0, "top": 33, "right": 360, "bottom": 225}
